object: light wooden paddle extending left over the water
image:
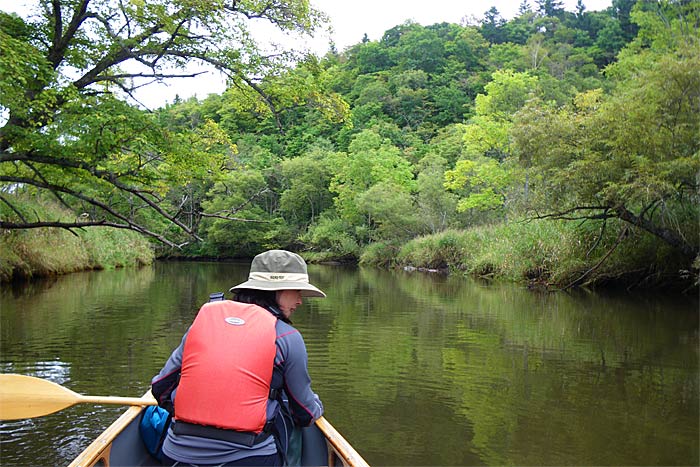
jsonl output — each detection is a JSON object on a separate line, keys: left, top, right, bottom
{"left": 0, "top": 374, "right": 156, "bottom": 420}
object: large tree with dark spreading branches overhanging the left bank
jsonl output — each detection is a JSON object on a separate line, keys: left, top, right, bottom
{"left": 0, "top": 0, "right": 322, "bottom": 245}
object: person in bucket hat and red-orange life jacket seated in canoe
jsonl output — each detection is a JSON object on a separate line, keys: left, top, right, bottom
{"left": 151, "top": 250, "right": 326, "bottom": 466}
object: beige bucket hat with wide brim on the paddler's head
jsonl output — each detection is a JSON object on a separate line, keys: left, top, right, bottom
{"left": 229, "top": 250, "right": 326, "bottom": 297}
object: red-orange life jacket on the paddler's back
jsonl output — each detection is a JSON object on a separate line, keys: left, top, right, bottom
{"left": 175, "top": 300, "right": 277, "bottom": 433}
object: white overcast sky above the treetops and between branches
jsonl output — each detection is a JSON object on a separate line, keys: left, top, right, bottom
{"left": 0, "top": 0, "right": 612, "bottom": 108}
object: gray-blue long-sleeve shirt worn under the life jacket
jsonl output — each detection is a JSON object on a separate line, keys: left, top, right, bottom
{"left": 151, "top": 310, "right": 323, "bottom": 464}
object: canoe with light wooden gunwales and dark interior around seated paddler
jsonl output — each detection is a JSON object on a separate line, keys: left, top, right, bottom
{"left": 68, "top": 393, "right": 369, "bottom": 467}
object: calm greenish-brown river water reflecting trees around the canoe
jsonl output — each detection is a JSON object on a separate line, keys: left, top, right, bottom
{"left": 0, "top": 263, "right": 700, "bottom": 466}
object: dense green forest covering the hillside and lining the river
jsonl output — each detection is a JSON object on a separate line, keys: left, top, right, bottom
{"left": 0, "top": 0, "right": 700, "bottom": 291}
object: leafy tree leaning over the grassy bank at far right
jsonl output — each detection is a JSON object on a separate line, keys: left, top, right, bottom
{"left": 513, "top": 44, "right": 700, "bottom": 261}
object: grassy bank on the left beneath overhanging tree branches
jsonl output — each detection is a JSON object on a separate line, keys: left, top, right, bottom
{"left": 0, "top": 197, "right": 154, "bottom": 282}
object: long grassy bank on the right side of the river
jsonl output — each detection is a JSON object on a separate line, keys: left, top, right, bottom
{"left": 360, "top": 220, "right": 700, "bottom": 290}
